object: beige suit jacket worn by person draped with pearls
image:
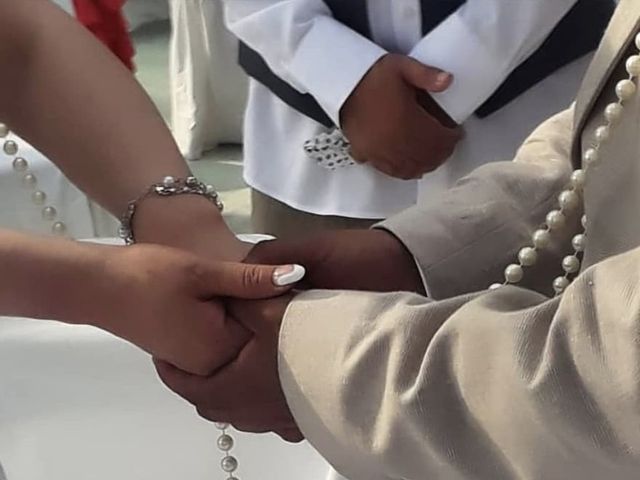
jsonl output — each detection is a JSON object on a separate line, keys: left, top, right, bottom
{"left": 280, "top": 0, "right": 640, "bottom": 480}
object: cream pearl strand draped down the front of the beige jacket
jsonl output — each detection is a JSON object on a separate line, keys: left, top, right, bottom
{"left": 489, "top": 34, "right": 640, "bottom": 295}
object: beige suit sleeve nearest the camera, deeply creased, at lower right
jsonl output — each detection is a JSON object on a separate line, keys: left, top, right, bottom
{"left": 280, "top": 250, "right": 640, "bottom": 480}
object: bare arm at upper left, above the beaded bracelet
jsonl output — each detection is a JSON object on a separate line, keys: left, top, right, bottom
{"left": 0, "top": 0, "right": 188, "bottom": 215}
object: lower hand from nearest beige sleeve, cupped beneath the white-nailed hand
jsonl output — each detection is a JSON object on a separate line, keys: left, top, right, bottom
{"left": 156, "top": 296, "right": 303, "bottom": 442}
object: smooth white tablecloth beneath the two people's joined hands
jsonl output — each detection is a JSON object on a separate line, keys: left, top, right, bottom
{"left": 0, "top": 237, "right": 326, "bottom": 480}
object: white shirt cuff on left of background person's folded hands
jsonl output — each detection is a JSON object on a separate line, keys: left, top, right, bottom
{"left": 290, "top": 17, "right": 387, "bottom": 125}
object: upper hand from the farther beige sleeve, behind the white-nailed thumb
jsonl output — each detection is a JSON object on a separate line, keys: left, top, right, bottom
{"left": 247, "top": 229, "right": 424, "bottom": 293}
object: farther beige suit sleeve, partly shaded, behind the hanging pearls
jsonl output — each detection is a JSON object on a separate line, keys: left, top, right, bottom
{"left": 377, "top": 108, "right": 577, "bottom": 300}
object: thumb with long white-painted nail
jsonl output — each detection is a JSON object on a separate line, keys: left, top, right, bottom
{"left": 199, "top": 262, "right": 306, "bottom": 299}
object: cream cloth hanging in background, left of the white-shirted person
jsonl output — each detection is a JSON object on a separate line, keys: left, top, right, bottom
{"left": 170, "top": 0, "right": 248, "bottom": 160}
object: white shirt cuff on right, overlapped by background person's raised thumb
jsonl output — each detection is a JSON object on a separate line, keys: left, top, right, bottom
{"left": 410, "top": 14, "right": 512, "bottom": 124}
